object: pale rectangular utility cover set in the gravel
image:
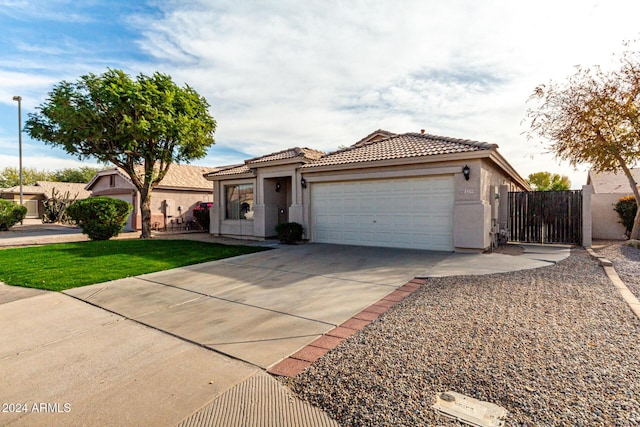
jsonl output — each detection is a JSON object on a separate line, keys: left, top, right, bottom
{"left": 433, "top": 391, "right": 507, "bottom": 427}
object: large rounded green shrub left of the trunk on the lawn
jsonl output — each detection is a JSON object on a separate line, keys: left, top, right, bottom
{"left": 67, "top": 197, "right": 133, "bottom": 240}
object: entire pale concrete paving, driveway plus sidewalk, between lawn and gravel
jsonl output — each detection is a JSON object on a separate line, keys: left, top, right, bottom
{"left": 0, "top": 244, "right": 569, "bottom": 426}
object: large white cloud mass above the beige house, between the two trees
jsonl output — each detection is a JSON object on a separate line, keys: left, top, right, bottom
{"left": 131, "top": 0, "right": 640, "bottom": 186}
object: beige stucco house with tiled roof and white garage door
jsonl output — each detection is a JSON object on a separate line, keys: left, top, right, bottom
{"left": 205, "top": 130, "right": 530, "bottom": 251}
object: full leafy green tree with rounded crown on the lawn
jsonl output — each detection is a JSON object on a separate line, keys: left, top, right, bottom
{"left": 25, "top": 69, "right": 216, "bottom": 238}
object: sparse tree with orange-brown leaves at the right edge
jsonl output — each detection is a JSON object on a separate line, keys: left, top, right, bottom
{"left": 527, "top": 44, "right": 640, "bottom": 239}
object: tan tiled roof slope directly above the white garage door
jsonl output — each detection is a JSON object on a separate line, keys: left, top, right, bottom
{"left": 302, "top": 133, "right": 498, "bottom": 169}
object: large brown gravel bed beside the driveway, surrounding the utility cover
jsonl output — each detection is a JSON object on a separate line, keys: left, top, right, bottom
{"left": 284, "top": 249, "right": 640, "bottom": 426}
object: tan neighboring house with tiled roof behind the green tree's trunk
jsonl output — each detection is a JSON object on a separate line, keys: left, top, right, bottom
{"left": 86, "top": 164, "right": 219, "bottom": 231}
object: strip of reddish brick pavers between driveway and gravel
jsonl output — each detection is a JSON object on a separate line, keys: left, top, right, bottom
{"left": 267, "top": 279, "right": 426, "bottom": 377}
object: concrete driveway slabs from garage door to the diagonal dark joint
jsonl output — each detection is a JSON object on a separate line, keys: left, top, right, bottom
{"left": 65, "top": 244, "right": 450, "bottom": 369}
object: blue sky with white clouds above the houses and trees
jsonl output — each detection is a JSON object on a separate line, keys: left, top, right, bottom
{"left": 0, "top": 0, "right": 640, "bottom": 188}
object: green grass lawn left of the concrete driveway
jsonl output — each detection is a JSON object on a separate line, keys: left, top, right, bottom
{"left": 0, "top": 240, "right": 265, "bottom": 291}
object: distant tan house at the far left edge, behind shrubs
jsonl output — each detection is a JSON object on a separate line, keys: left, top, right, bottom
{"left": 0, "top": 181, "right": 91, "bottom": 218}
